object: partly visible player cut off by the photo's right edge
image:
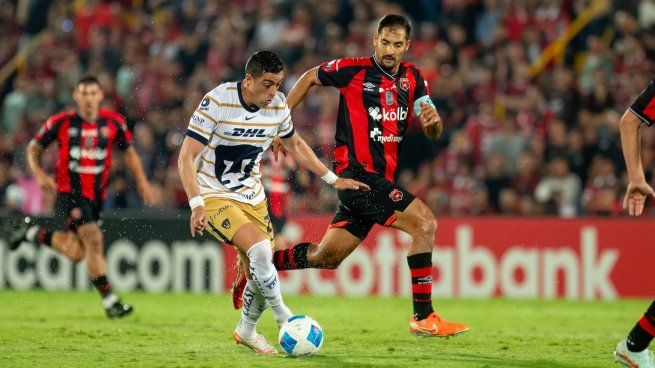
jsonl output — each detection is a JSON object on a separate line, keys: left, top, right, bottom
{"left": 614, "top": 80, "right": 655, "bottom": 368}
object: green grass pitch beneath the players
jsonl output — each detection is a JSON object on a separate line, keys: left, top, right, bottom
{"left": 0, "top": 291, "right": 649, "bottom": 368}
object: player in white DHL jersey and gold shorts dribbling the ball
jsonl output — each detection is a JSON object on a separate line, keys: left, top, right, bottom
{"left": 178, "top": 51, "right": 370, "bottom": 354}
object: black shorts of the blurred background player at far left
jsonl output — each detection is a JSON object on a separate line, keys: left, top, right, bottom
{"left": 55, "top": 193, "right": 102, "bottom": 231}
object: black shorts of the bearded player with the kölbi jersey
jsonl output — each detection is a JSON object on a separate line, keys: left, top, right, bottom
{"left": 330, "top": 168, "right": 416, "bottom": 239}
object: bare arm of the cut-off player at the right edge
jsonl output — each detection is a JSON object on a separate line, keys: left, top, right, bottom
{"left": 619, "top": 110, "right": 655, "bottom": 216}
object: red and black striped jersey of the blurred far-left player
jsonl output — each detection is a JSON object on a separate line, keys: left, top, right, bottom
{"left": 34, "top": 109, "right": 132, "bottom": 201}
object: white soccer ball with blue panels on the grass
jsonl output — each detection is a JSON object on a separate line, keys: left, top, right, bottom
{"left": 279, "top": 314, "right": 323, "bottom": 357}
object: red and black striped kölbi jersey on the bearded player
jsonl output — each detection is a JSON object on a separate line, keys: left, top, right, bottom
{"left": 317, "top": 57, "right": 429, "bottom": 182}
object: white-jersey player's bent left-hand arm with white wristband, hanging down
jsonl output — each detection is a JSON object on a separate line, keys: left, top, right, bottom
{"left": 177, "top": 137, "right": 207, "bottom": 237}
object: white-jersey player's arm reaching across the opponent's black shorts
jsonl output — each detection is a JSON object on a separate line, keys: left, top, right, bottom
{"left": 282, "top": 133, "right": 371, "bottom": 190}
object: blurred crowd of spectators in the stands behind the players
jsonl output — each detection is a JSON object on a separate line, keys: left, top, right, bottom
{"left": 0, "top": 0, "right": 655, "bottom": 217}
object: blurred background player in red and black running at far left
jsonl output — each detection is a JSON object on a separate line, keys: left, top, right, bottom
{"left": 11, "top": 77, "right": 154, "bottom": 318}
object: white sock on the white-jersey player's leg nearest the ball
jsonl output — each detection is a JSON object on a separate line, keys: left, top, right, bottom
{"left": 244, "top": 240, "right": 292, "bottom": 326}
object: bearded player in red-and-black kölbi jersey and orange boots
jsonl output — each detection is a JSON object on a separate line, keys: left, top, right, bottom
{"left": 274, "top": 15, "right": 468, "bottom": 336}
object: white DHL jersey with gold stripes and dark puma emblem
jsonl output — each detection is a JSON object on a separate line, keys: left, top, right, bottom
{"left": 186, "top": 82, "right": 294, "bottom": 205}
